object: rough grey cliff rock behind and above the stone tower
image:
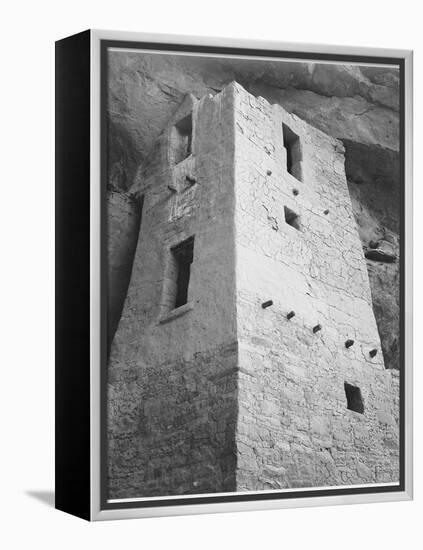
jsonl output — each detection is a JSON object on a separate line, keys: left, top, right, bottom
{"left": 108, "top": 51, "right": 400, "bottom": 368}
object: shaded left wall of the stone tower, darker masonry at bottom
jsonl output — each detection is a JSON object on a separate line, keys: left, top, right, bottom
{"left": 108, "top": 87, "right": 242, "bottom": 498}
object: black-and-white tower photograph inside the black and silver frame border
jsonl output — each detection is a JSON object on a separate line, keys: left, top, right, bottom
{"left": 103, "top": 47, "right": 403, "bottom": 503}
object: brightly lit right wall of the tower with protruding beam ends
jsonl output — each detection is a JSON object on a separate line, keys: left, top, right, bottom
{"left": 235, "top": 87, "right": 399, "bottom": 490}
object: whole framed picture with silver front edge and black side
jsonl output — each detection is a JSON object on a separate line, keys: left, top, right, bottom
{"left": 56, "top": 30, "right": 412, "bottom": 520}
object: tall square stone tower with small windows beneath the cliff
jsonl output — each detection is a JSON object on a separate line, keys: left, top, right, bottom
{"left": 108, "top": 83, "right": 399, "bottom": 498}
